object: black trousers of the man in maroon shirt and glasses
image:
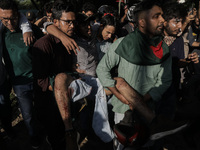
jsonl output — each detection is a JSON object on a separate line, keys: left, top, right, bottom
{"left": 35, "top": 91, "right": 65, "bottom": 150}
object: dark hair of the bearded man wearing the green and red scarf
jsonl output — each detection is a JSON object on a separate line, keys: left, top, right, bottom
{"left": 134, "top": 0, "right": 161, "bottom": 24}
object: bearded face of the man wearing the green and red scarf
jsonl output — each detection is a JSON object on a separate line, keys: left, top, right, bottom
{"left": 144, "top": 6, "right": 164, "bottom": 37}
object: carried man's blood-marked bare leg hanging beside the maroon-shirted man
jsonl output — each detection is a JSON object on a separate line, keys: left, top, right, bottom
{"left": 54, "top": 73, "right": 79, "bottom": 150}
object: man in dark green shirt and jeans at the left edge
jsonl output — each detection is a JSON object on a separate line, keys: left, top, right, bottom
{"left": 0, "top": 0, "right": 40, "bottom": 148}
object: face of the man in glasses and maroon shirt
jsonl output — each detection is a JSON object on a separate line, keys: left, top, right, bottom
{"left": 57, "top": 12, "right": 76, "bottom": 36}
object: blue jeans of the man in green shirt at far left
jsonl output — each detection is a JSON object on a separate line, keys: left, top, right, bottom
{"left": 13, "top": 83, "right": 35, "bottom": 136}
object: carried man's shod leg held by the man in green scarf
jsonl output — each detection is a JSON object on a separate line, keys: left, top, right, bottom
{"left": 115, "top": 77, "right": 187, "bottom": 140}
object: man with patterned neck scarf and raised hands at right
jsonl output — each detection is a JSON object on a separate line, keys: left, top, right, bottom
{"left": 163, "top": 3, "right": 199, "bottom": 100}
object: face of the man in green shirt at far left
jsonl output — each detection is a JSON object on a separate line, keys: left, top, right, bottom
{"left": 0, "top": 8, "right": 18, "bottom": 32}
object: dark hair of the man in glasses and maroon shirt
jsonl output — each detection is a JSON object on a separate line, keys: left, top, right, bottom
{"left": 52, "top": 1, "right": 74, "bottom": 19}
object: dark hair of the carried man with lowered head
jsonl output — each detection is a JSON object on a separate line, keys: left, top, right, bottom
{"left": 101, "top": 13, "right": 117, "bottom": 28}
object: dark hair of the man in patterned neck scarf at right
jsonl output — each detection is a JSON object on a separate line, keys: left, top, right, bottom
{"left": 162, "top": 2, "right": 182, "bottom": 21}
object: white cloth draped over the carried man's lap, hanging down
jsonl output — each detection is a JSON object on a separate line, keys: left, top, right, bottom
{"left": 69, "top": 75, "right": 114, "bottom": 143}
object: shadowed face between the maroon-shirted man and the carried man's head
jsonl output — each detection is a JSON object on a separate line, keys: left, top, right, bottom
{"left": 79, "top": 21, "right": 92, "bottom": 38}
